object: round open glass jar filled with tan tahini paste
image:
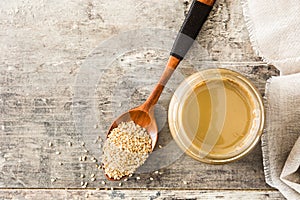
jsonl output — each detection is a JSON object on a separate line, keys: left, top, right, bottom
{"left": 168, "top": 69, "right": 264, "bottom": 164}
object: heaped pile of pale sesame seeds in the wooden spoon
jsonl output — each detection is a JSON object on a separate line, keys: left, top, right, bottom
{"left": 102, "top": 121, "right": 152, "bottom": 180}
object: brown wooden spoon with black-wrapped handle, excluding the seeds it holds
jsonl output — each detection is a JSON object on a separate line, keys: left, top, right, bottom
{"left": 106, "top": 0, "right": 215, "bottom": 180}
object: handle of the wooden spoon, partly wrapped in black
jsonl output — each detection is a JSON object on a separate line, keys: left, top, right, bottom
{"left": 141, "top": 0, "right": 215, "bottom": 111}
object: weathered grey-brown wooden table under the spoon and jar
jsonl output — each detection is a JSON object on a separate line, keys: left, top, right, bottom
{"left": 0, "top": 0, "right": 283, "bottom": 199}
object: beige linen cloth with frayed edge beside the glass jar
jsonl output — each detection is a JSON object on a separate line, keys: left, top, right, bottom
{"left": 242, "top": 0, "right": 300, "bottom": 200}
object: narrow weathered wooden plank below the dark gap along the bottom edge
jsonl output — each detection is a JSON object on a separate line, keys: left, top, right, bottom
{"left": 0, "top": 189, "right": 282, "bottom": 200}
